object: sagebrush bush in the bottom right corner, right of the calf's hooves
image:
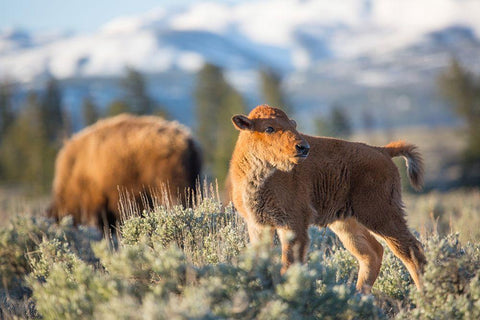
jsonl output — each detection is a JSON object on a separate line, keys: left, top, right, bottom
{"left": 398, "top": 234, "right": 480, "bottom": 319}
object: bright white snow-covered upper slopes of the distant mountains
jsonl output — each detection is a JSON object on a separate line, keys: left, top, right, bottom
{"left": 0, "top": 0, "right": 480, "bottom": 81}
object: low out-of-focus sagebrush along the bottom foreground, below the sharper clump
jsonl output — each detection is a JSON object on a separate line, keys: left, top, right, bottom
{"left": 29, "top": 234, "right": 382, "bottom": 319}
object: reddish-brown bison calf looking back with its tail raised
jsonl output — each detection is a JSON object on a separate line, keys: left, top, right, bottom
{"left": 229, "top": 105, "right": 426, "bottom": 292}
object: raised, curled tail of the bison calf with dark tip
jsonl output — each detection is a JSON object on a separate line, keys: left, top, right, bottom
{"left": 384, "top": 141, "right": 423, "bottom": 191}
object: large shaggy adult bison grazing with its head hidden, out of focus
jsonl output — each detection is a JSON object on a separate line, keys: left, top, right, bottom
{"left": 49, "top": 115, "right": 201, "bottom": 228}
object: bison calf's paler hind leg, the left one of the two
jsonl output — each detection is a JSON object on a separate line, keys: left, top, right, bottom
{"left": 328, "top": 218, "right": 383, "bottom": 293}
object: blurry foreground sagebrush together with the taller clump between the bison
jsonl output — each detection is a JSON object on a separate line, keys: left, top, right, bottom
{"left": 29, "top": 198, "right": 383, "bottom": 319}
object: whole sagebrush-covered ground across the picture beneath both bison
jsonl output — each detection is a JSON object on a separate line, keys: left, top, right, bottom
{"left": 0, "top": 190, "right": 480, "bottom": 319}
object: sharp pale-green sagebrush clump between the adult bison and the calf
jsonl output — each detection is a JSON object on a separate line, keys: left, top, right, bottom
{"left": 121, "top": 202, "right": 248, "bottom": 265}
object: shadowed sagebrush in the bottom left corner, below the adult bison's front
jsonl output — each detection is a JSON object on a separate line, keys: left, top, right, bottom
{"left": 0, "top": 216, "right": 101, "bottom": 317}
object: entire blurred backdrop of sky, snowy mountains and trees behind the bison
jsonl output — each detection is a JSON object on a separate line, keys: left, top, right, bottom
{"left": 0, "top": 0, "right": 480, "bottom": 195}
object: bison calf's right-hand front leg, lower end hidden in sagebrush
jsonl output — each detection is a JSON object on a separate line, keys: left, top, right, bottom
{"left": 277, "top": 226, "right": 310, "bottom": 274}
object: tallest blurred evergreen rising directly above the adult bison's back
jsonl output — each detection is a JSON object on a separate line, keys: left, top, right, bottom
{"left": 121, "top": 67, "right": 156, "bottom": 114}
